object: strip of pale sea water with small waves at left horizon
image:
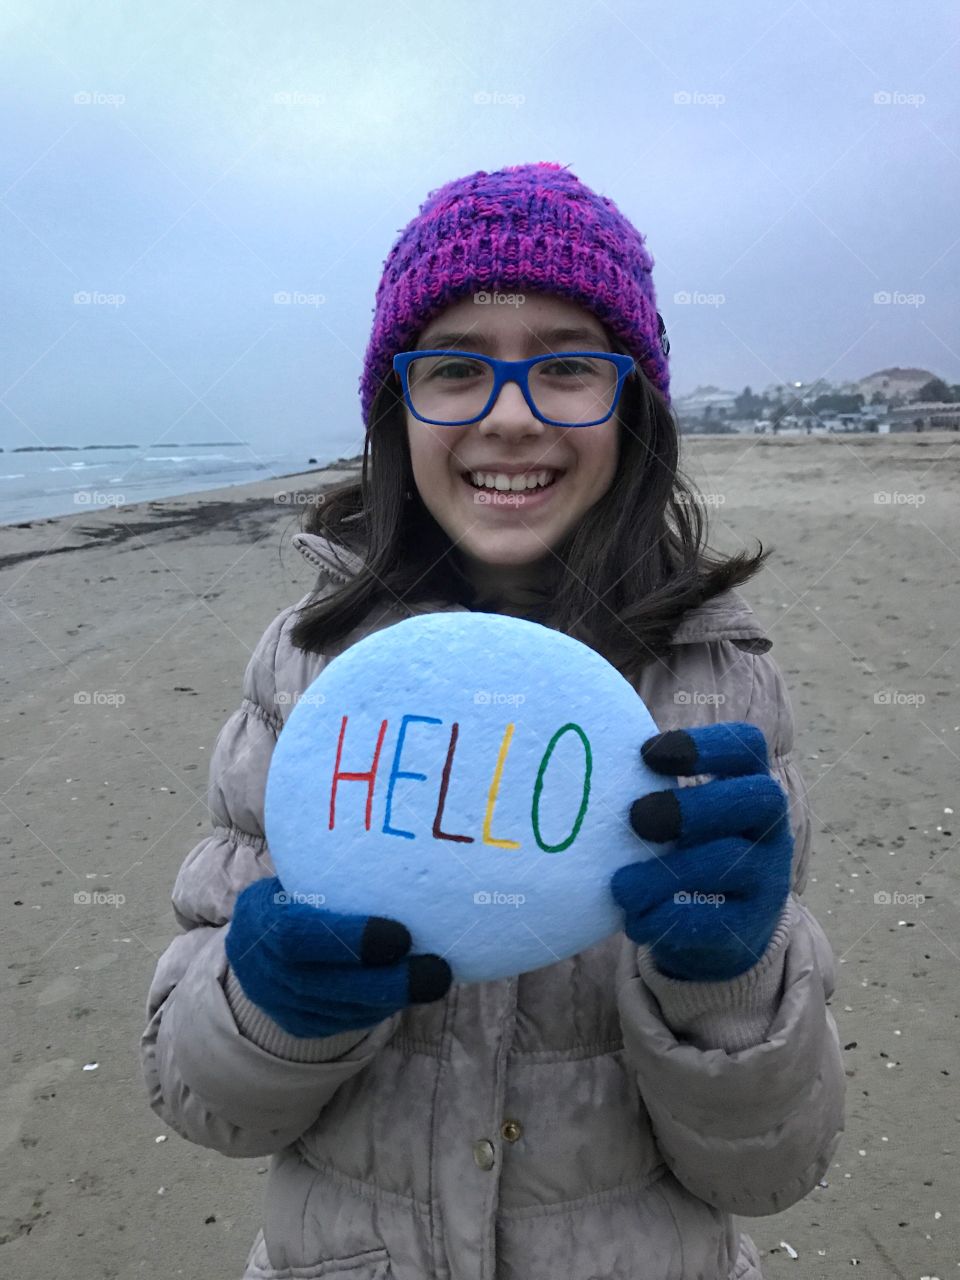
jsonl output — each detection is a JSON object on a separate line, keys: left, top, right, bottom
{"left": 0, "top": 444, "right": 349, "bottom": 525}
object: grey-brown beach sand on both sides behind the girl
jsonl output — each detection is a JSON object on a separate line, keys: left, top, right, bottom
{"left": 0, "top": 434, "right": 960, "bottom": 1280}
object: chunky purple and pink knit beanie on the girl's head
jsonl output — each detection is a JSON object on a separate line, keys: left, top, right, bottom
{"left": 360, "top": 163, "right": 669, "bottom": 422}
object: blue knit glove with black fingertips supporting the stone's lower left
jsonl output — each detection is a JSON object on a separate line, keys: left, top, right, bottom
{"left": 225, "top": 876, "right": 452, "bottom": 1037}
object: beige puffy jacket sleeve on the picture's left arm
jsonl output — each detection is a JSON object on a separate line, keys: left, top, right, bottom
{"left": 140, "top": 600, "right": 398, "bottom": 1157}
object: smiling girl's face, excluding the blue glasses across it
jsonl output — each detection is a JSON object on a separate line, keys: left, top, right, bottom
{"left": 404, "top": 293, "right": 618, "bottom": 570}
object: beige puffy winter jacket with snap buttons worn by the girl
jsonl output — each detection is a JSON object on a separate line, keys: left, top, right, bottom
{"left": 141, "top": 534, "right": 845, "bottom": 1280}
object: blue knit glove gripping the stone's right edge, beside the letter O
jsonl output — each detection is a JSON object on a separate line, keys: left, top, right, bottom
{"left": 611, "top": 722, "right": 794, "bottom": 982}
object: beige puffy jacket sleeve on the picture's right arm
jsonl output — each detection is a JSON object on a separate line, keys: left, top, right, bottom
{"left": 617, "top": 641, "right": 846, "bottom": 1216}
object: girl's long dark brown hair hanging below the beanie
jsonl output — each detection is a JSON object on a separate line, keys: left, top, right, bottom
{"left": 292, "top": 355, "right": 769, "bottom": 680}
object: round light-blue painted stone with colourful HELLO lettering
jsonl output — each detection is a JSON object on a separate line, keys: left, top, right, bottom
{"left": 265, "top": 612, "right": 672, "bottom": 982}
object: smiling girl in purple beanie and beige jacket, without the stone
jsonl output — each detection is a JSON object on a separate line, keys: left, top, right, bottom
{"left": 142, "top": 164, "right": 844, "bottom": 1280}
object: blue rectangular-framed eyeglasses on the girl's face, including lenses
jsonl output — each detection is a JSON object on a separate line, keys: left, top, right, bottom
{"left": 393, "top": 351, "right": 636, "bottom": 426}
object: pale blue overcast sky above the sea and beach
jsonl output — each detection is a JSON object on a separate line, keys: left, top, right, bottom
{"left": 0, "top": 0, "right": 960, "bottom": 456}
